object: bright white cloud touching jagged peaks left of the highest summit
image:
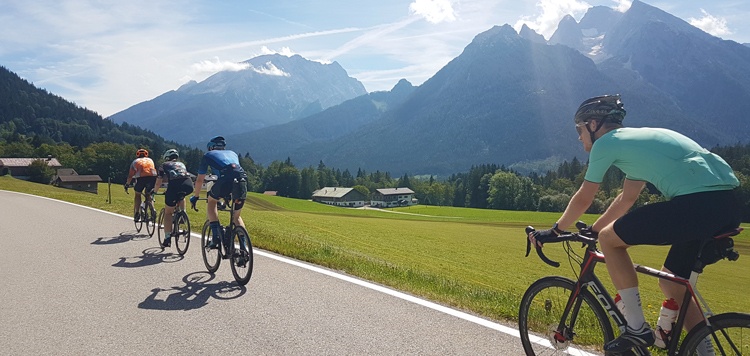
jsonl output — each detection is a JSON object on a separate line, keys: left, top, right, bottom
{"left": 513, "top": 0, "right": 591, "bottom": 39}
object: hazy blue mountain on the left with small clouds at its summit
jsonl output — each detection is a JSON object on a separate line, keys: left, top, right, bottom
{"left": 108, "top": 54, "right": 367, "bottom": 143}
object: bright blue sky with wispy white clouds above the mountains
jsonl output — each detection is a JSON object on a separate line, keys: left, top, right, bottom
{"left": 0, "top": 0, "right": 750, "bottom": 117}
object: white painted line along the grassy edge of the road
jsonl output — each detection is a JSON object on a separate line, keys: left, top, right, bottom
{"left": 0, "top": 190, "right": 594, "bottom": 356}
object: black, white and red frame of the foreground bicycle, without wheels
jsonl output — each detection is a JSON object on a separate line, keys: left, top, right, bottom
{"left": 555, "top": 246, "right": 711, "bottom": 355}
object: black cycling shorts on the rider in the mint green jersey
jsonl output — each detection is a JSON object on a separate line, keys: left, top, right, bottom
{"left": 614, "top": 190, "right": 742, "bottom": 278}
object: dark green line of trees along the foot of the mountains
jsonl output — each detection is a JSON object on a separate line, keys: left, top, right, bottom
{"left": 0, "top": 135, "right": 750, "bottom": 221}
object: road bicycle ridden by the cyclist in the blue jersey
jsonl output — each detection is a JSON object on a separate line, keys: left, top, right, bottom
{"left": 194, "top": 195, "right": 253, "bottom": 286}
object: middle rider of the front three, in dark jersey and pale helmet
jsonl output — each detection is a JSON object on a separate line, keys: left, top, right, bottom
{"left": 151, "top": 148, "right": 193, "bottom": 247}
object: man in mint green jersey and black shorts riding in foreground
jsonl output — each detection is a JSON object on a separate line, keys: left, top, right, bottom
{"left": 529, "top": 95, "right": 741, "bottom": 352}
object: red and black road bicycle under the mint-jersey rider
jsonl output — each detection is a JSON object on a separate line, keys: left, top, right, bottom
{"left": 518, "top": 222, "right": 750, "bottom": 355}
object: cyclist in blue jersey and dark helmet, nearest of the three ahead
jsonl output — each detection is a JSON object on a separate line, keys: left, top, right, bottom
{"left": 190, "top": 136, "right": 247, "bottom": 248}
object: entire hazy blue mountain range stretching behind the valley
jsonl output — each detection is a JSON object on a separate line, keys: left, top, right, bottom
{"left": 106, "top": 0, "right": 750, "bottom": 175}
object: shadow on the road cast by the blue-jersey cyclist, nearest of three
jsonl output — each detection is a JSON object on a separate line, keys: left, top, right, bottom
{"left": 138, "top": 272, "right": 247, "bottom": 310}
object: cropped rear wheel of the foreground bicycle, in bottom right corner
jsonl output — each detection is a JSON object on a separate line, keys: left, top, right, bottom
{"left": 680, "top": 313, "right": 750, "bottom": 355}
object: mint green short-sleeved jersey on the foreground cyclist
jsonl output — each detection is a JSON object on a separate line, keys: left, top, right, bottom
{"left": 585, "top": 127, "right": 740, "bottom": 199}
